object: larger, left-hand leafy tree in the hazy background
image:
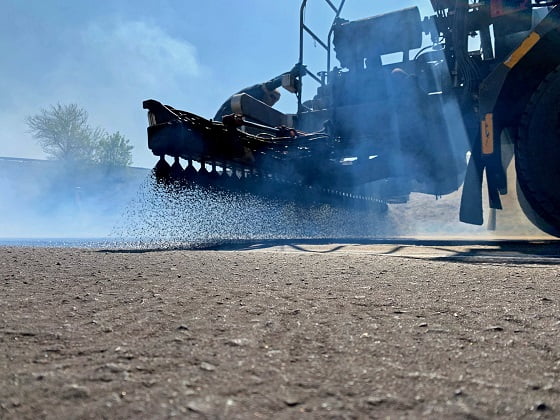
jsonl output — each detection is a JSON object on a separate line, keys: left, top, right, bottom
{"left": 26, "top": 104, "right": 105, "bottom": 161}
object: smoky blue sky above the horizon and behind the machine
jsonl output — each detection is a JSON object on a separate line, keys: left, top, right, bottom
{"left": 0, "top": 0, "right": 431, "bottom": 167}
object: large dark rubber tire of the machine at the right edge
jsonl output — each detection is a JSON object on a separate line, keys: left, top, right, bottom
{"left": 515, "top": 66, "right": 560, "bottom": 236}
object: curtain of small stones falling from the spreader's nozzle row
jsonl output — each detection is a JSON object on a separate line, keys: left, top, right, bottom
{"left": 111, "top": 173, "right": 394, "bottom": 246}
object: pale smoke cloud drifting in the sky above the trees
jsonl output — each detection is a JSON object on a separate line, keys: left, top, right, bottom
{"left": 0, "top": 16, "right": 206, "bottom": 166}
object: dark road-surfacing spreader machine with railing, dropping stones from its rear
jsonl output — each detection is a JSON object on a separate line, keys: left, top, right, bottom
{"left": 143, "top": 0, "right": 560, "bottom": 236}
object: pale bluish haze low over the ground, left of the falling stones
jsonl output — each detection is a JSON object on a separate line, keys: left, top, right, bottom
{"left": 0, "top": 159, "right": 148, "bottom": 238}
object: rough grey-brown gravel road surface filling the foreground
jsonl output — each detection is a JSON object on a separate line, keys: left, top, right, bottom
{"left": 0, "top": 244, "right": 560, "bottom": 419}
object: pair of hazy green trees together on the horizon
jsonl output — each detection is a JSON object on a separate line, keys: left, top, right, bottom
{"left": 26, "top": 104, "right": 133, "bottom": 167}
